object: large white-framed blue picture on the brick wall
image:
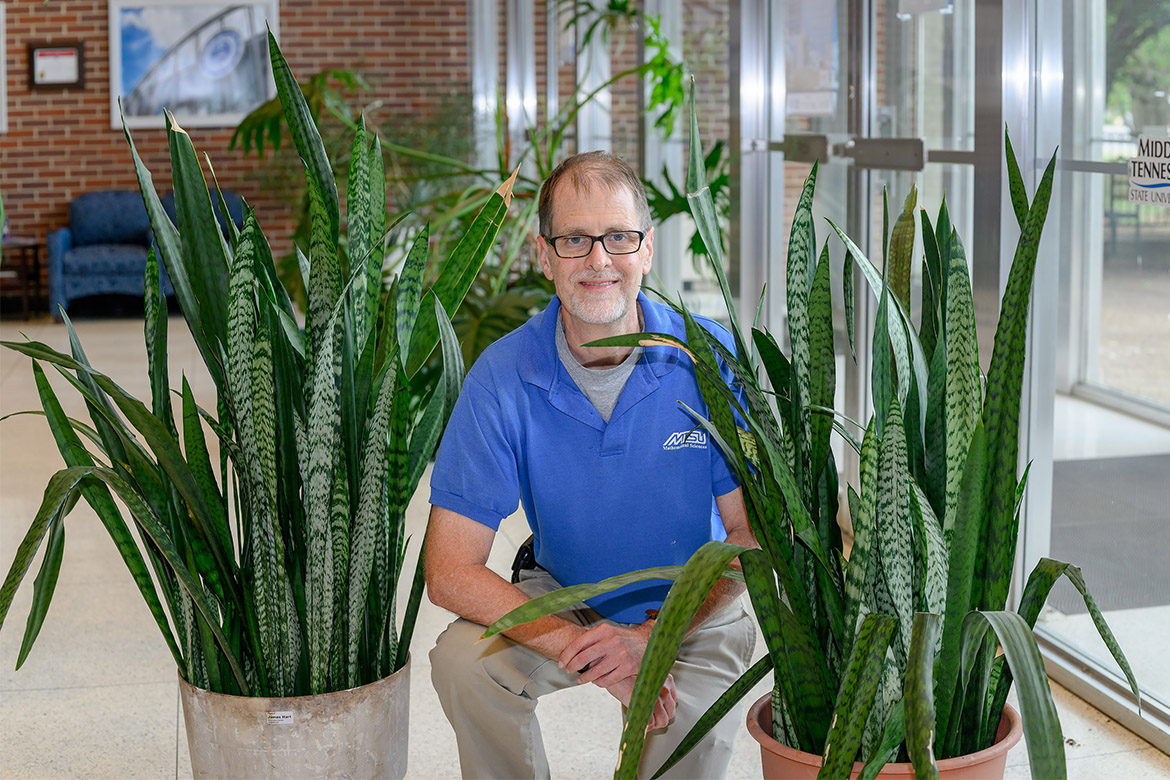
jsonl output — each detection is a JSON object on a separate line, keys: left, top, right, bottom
{"left": 109, "top": 0, "right": 280, "bottom": 129}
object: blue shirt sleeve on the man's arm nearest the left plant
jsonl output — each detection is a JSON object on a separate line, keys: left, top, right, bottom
{"left": 431, "top": 368, "right": 519, "bottom": 530}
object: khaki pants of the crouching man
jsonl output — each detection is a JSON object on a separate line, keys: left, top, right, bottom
{"left": 431, "top": 570, "right": 756, "bottom": 780}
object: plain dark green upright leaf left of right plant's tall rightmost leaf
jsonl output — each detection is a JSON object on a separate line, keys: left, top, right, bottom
{"left": 935, "top": 422, "right": 987, "bottom": 753}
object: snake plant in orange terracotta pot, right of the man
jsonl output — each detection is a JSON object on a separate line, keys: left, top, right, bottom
{"left": 489, "top": 90, "right": 1138, "bottom": 778}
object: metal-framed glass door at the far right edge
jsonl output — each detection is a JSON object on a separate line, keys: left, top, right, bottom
{"left": 1024, "top": 0, "right": 1170, "bottom": 750}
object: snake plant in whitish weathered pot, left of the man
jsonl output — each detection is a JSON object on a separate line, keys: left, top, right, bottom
{"left": 0, "top": 35, "right": 510, "bottom": 778}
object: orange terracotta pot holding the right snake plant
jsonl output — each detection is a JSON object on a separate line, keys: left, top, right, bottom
{"left": 748, "top": 693, "right": 1024, "bottom": 780}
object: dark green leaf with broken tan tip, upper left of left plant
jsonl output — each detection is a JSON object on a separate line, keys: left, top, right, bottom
{"left": 165, "top": 112, "right": 228, "bottom": 357}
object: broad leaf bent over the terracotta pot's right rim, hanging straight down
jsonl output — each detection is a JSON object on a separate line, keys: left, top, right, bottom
{"left": 962, "top": 612, "right": 1067, "bottom": 778}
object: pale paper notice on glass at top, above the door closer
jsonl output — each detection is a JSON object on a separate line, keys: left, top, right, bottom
{"left": 784, "top": 0, "right": 838, "bottom": 117}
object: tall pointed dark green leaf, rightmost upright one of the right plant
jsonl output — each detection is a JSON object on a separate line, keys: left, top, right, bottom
{"left": 982, "top": 153, "right": 1057, "bottom": 609}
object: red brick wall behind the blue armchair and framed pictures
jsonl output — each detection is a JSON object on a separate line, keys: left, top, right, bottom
{"left": 0, "top": 0, "right": 469, "bottom": 301}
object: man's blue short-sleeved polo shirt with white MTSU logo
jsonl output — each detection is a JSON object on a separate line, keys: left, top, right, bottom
{"left": 431, "top": 294, "right": 737, "bottom": 623}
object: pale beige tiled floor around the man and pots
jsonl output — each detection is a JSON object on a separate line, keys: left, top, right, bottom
{"left": 0, "top": 319, "right": 1170, "bottom": 780}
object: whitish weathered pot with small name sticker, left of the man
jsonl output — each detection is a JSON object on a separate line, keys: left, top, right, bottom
{"left": 179, "top": 657, "right": 411, "bottom": 780}
